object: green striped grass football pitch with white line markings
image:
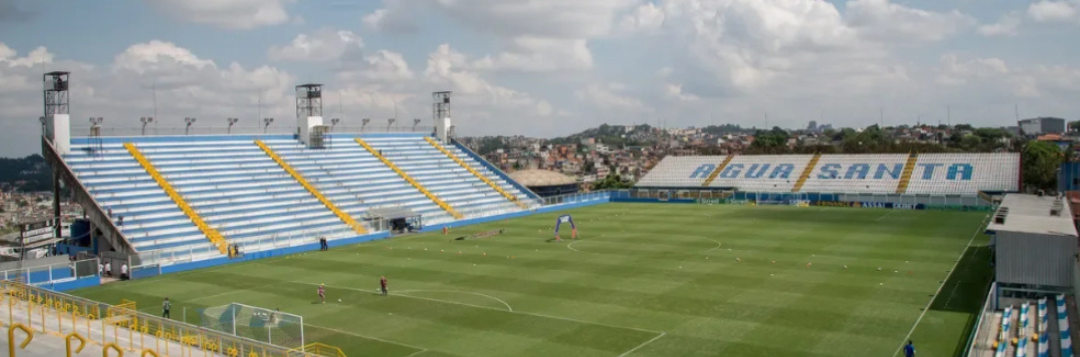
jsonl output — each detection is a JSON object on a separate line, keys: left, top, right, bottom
{"left": 75, "top": 204, "right": 989, "bottom": 357}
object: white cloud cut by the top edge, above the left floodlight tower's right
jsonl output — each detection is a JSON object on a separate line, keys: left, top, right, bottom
{"left": 147, "top": 0, "right": 295, "bottom": 29}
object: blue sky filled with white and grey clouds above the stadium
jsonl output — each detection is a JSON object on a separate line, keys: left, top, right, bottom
{"left": 0, "top": 0, "right": 1080, "bottom": 156}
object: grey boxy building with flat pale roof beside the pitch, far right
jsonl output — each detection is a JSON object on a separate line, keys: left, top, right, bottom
{"left": 986, "top": 194, "right": 1078, "bottom": 299}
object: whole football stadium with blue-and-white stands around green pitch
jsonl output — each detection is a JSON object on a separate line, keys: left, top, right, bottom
{"left": 0, "top": 76, "right": 1078, "bottom": 357}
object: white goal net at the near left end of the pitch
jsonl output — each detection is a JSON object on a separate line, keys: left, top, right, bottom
{"left": 199, "top": 303, "right": 303, "bottom": 348}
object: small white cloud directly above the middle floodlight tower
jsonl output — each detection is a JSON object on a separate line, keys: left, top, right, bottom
{"left": 267, "top": 29, "right": 364, "bottom": 63}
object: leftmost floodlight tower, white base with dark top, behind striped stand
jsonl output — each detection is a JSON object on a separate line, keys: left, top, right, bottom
{"left": 41, "top": 71, "right": 71, "bottom": 155}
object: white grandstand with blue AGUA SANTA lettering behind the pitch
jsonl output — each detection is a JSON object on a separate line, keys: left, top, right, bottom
{"left": 636, "top": 153, "right": 1021, "bottom": 195}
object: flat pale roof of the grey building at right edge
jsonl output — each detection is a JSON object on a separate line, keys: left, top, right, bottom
{"left": 986, "top": 193, "right": 1077, "bottom": 237}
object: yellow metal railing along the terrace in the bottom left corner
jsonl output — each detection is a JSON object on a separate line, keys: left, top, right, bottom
{"left": 0, "top": 280, "right": 315, "bottom": 357}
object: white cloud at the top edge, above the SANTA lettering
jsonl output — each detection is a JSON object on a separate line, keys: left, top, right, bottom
{"left": 845, "top": 0, "right": 975, "bottom": 42}
